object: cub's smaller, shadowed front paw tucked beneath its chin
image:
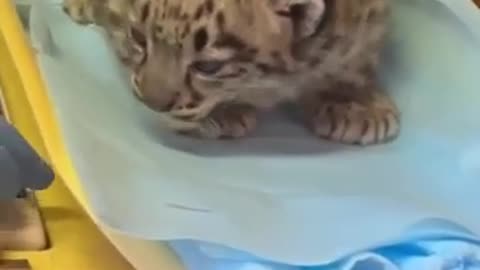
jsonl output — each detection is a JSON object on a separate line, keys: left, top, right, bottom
{"left": 195, "top": 104, "right": 257, "bottom": 139}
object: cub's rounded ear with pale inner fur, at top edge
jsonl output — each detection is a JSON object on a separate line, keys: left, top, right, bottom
{"left": 267, "top": 0, "right": 325, "bottom": 39}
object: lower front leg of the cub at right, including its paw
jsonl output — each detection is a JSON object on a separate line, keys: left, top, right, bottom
{"left": 302, "top": 82, "right": 400, "bottom": 145}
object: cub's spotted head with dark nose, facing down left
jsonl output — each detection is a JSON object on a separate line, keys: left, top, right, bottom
{"left": 129, "top": 0, "right": 324, "bottom": 125}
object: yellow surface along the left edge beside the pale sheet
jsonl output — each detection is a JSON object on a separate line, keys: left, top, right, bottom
{"left": 0, "top": 0, "right": 145, "bottom": 270}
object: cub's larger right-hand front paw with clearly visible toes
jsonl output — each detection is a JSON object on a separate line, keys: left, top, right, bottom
{"left": 308, "top": 93, "right": 400, "bottom": 145}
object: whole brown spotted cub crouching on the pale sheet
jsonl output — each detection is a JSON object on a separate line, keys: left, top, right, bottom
{"left": 64, "top": 0, "right": 399, "bottom": 145}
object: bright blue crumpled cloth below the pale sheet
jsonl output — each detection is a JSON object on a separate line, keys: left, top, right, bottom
{"left": 170, "top": 233, "right": 480, "bottom": 270}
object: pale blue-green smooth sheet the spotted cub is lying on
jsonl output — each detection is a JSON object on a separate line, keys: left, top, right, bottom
{"left": 30, "top": 0, "right": 480, "bottom": 264}
